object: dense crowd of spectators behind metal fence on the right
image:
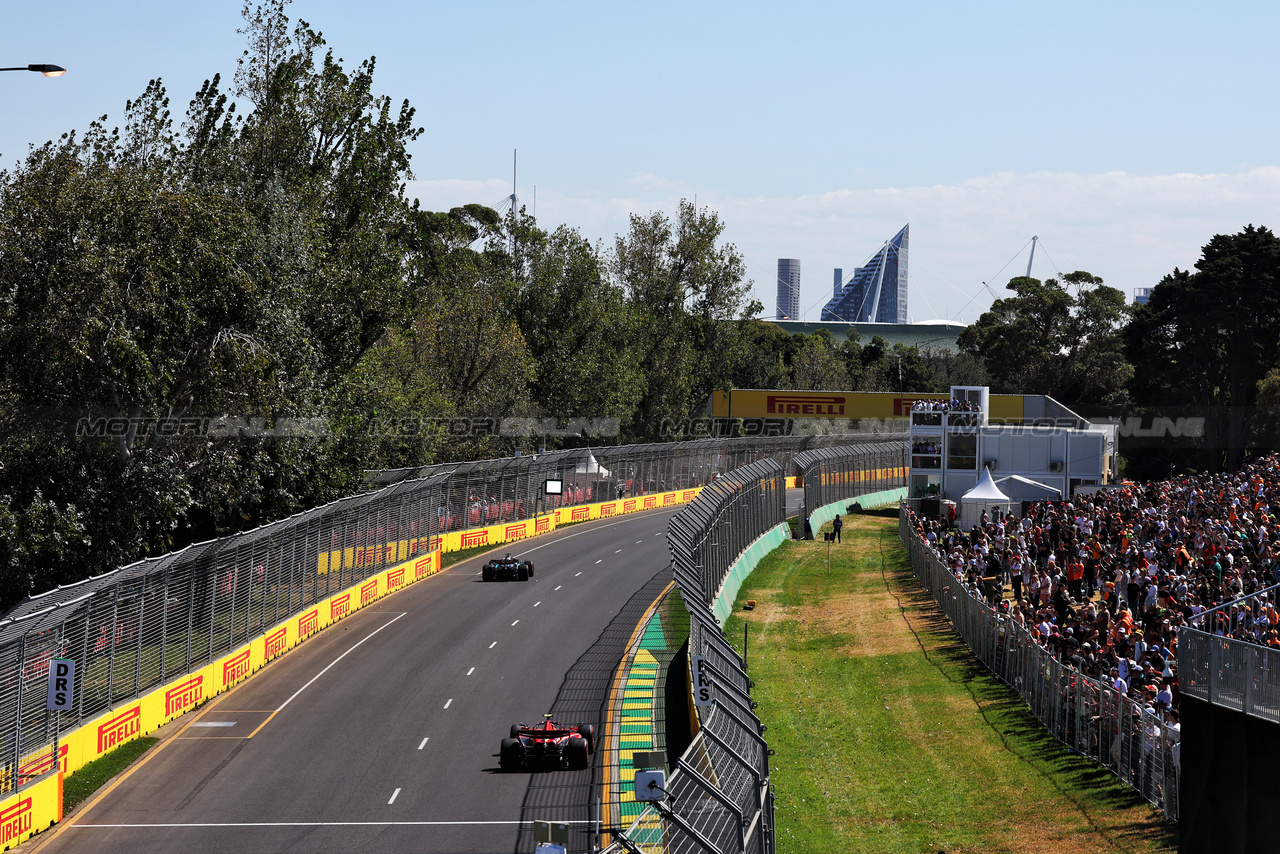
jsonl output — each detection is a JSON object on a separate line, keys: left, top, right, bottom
{"left": 914, "top": 455, "right": 1280, "bottom": 742}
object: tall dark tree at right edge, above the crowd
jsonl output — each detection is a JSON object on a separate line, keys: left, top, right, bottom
{"left": 1124, "top": 225, "right": 1280, "bottom": 470}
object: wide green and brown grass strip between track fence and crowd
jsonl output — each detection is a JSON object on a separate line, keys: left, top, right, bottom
{"left": 724, "top": 515, "right": 1176, "bottom": 854}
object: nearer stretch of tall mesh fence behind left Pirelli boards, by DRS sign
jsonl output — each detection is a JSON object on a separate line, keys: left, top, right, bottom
{"left": 0, "top": 476, "right": 445, "bottom": 796}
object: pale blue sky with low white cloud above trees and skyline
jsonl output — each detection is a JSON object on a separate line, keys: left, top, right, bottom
{"left": 0, "top": 0, "right": 1280, "bottom": 321}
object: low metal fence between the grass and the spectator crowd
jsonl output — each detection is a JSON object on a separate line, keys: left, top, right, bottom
{"left": 899, "top": 502, "right": 1177, "bottom": 821}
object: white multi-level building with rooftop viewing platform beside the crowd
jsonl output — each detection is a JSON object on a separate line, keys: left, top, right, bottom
{"left": 909, "top": 385, "right": 1117, "bottom": 501}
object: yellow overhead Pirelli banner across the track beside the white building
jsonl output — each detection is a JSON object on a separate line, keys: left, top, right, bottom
{"left": 712, "top": 388, "right": 1023, "bottom": 421}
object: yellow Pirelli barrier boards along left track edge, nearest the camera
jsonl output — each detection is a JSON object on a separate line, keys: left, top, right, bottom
{"left": 11, "top": 551, "right": 440, "bottom": 829}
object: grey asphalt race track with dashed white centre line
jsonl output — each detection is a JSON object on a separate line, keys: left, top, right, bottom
{"left": 35, "top": 511, "right": 673, "bottom": 854}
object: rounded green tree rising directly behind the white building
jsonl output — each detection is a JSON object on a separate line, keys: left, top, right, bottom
{"left": 956, "top": 270, "right": 1133, "bottom": 405}
